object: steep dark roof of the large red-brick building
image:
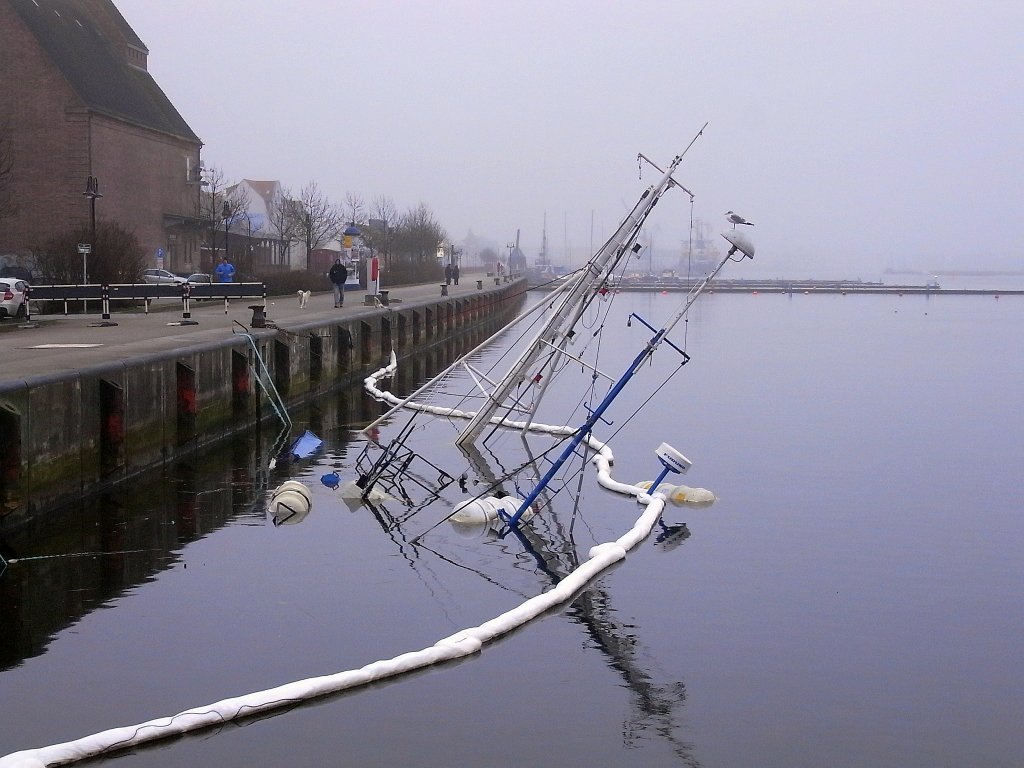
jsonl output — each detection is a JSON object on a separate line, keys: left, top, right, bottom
{"left": 9, "top": 0, "right": 202, "bottom": 143}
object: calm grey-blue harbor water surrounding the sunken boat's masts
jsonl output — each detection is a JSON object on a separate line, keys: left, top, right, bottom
{"left": 0, "top": 286, "right": 1024, "bottom": 768}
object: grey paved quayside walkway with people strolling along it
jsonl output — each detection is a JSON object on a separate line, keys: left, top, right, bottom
{"left": 0, "top": 275, "right": 512, "bottom": 382}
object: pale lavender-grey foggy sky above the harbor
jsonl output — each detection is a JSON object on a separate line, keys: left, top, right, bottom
{"left": 115, "top": 0, "right": 1024, "bottom": 279}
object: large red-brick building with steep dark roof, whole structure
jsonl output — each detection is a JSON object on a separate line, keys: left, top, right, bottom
{"left": 0, "top": 0, "right": 203, "bottom": 272}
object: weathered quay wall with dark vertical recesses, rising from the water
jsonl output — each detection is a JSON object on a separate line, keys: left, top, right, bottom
{"left": 0, "top": 281, "right": 525, "bottom": 523}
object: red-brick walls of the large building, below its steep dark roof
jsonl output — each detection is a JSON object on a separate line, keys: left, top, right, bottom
{"left": 0, "top": 0, "right": 200, "bottom": 271}
